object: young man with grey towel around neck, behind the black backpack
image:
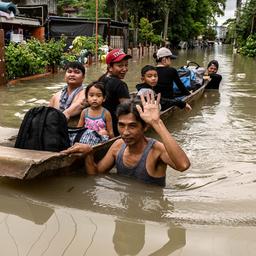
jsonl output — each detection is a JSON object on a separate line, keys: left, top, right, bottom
{"left": 49, "top": 62, "right": 85, "bottom": 120}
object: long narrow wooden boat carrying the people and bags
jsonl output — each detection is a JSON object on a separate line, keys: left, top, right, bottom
{"left": 0, "top": 81, "right": 206, "bottom": 180}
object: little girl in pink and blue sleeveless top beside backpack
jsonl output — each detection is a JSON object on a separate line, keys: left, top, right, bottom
{"left": 77, "top": 81, "right": 114, "bottom": 138}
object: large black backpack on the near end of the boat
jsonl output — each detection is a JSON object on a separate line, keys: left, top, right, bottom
{"left": 15, "top": 106, "right": 70, "bottom": 152}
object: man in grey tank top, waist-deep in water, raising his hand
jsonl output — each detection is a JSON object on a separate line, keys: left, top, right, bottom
{"left": 63, "top": 94, "right": 190, "bottom": 186}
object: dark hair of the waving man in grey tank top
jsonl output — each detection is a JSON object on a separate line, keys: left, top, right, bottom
{"left": 116, "top": 98, "right": 147, "bottom": 127}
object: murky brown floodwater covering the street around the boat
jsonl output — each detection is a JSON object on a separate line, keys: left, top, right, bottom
{"left": 0, "top": 45, "right": 256, "bottom": 256}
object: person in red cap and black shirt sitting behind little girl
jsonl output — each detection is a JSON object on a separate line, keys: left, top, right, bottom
{"left": 98, "top": 49, "right": 132, "bottom": 136}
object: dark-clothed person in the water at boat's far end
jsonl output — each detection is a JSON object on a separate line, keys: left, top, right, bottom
{"left": 205, "top": 60, "right": 222, "bottom": 89}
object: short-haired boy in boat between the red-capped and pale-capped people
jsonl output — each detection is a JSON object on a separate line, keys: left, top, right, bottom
{"left": 136, "top": 65, "right": 192, "bottom": 111}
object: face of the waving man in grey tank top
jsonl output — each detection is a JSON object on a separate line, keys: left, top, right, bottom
{"left": 117, "top": 113, "right": 146, "bottom": 146}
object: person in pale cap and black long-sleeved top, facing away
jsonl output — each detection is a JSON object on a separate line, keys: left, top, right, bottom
{"left": 153, "top": 47, "right": 190, "bottom": 110}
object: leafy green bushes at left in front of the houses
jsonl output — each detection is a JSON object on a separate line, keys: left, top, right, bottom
{"left": 5, "top": 36, "right": 104, "bottom": 80}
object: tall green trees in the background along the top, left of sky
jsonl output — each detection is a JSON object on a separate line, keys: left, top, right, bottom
{"left": 57, "top": 0, "right": 226, "bottom": 47}
